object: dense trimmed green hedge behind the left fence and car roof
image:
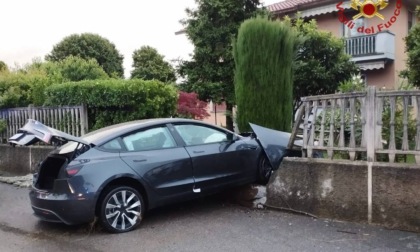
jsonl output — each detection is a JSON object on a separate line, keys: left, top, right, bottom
{"left": 45, "top": 79, "right": 177, "bottom": 130}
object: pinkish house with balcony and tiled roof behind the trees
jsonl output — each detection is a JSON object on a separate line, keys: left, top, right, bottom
{"left": 267, "top": 0, "right": 420, "bottom": 89}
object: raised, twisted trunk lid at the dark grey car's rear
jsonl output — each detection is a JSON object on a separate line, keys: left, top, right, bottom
{"left": 8, "top": 119, "right": 89, "bottom": 146}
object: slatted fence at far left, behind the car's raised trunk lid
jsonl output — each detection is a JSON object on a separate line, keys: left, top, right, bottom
{"left": 0, "top": 106, "right": 88, "bottom": 143}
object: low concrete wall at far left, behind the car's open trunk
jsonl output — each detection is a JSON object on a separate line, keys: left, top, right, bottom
{"left": 0, "top": 144, "right": 54, "bottom": 175}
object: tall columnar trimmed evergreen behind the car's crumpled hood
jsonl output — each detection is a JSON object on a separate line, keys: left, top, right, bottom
{"left": 234, "top": 17, "right": 296, "bottom": 131}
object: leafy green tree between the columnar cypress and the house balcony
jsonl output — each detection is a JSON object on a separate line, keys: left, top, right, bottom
{"left": 290, "top": 18, "right": 358, "bottom": 115}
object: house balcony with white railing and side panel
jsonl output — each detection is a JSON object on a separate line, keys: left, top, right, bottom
{"left": 345, "top": 31, "right": 395, "bottom": 63}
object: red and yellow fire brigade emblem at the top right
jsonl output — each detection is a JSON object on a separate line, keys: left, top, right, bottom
{"left": 350, "top": 0, "right": 388, "bottom": 20}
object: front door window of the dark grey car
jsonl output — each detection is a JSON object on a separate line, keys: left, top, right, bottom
{"left": 175, "top": 124, "right": 227, "bottom": 146}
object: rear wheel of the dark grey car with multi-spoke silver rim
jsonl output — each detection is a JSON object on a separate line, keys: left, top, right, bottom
{"left": 99, "top": 186, "right": 145, "bottom": 233}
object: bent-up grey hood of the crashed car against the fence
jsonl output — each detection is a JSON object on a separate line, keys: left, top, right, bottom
{"left": 249, "top": 123, "right": 291, "bottom": 170}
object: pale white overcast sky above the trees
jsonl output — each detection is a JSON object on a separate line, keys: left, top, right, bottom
{"left": 0, "top": 0, "right": 279, "bottom": 76}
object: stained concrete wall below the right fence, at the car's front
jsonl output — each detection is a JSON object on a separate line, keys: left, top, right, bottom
{"left": 267, "top": 158, "right": 420, "bottom": 232}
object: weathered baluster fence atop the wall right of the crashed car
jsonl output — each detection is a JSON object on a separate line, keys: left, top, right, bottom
{"left": 289, "top": 87, "right": 420, "bottom": 164}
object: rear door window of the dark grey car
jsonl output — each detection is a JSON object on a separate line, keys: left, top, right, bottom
{"left": 122, "top": 127, "right": 176, "bottom": 151}
